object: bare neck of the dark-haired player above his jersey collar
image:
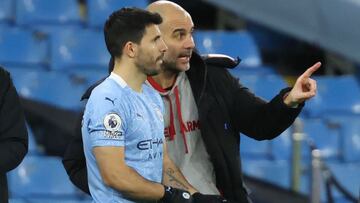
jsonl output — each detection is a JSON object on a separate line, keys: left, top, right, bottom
{"left": 112, "top": 61, "right": 146, "bottom": 92}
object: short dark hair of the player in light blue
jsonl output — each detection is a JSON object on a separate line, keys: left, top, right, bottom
{"left": 104, "top": 8, "right": 162, "bottom": 57}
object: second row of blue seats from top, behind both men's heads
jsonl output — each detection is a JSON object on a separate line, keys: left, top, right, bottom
{"left": 0, "top": 26, "right": 261, "bottom": 70}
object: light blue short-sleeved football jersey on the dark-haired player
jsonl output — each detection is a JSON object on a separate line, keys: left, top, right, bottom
{"left": 82, "top": 73, "right": 164, "bottom": 203}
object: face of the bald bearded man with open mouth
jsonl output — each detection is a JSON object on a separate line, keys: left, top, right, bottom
{"left": 160, "top": 11, "right": 195, "bottom": 72}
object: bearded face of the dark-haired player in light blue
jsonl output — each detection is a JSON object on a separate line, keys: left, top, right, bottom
{"left": 135, "top": 25, "right": 167, "bottom": 76}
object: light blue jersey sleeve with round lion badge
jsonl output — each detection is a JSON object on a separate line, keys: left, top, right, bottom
{"left": 87, "top": 95, "right": 130, "bottom": 147}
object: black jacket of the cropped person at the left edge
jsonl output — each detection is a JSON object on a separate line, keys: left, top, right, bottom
{"left": 0, "top": 67, "right": 28, "bottom": 203}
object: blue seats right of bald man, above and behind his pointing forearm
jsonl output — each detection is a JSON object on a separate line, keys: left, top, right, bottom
{"left": 230, "top": 70, "right": 360, "bottom": 118}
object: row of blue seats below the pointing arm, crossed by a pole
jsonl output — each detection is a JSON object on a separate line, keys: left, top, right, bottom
{"left": 241, "top": 116, "right": 360, "bottom": 163}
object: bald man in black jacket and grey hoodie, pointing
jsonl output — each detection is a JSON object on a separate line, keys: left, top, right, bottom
{"left": 63, "top": 1, "right": 320, "bottom": 203}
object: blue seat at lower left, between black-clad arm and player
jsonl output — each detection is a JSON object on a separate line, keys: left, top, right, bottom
{"left": 8, "top": 156, "right": 79, "bottom": 199}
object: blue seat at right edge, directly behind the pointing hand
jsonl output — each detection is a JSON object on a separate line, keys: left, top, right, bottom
{"left": 304, "top": 75, "right": 360, "bottom": 117}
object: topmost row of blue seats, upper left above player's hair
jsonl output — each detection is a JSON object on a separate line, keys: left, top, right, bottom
{"left": 0, "top": 0, "right": 148, "bottom": 28}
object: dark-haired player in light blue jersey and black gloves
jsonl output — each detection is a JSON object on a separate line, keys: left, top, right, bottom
{"left": 82, "top": 8, "right": 196, "bottom": 203}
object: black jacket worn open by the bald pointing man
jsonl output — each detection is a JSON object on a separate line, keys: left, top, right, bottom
{"left": 63, "top": 53, "right": 302, "bottom": 203}
